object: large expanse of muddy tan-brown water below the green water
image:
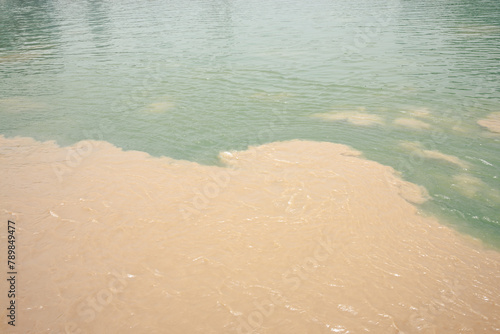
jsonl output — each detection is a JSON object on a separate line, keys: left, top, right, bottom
{"left": 0, "top": 137, "right": 500, "bottom": 333}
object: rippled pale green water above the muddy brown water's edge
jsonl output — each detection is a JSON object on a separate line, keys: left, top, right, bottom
{"left": 0, "top": 0, "right": 500, "bottom": 246}
